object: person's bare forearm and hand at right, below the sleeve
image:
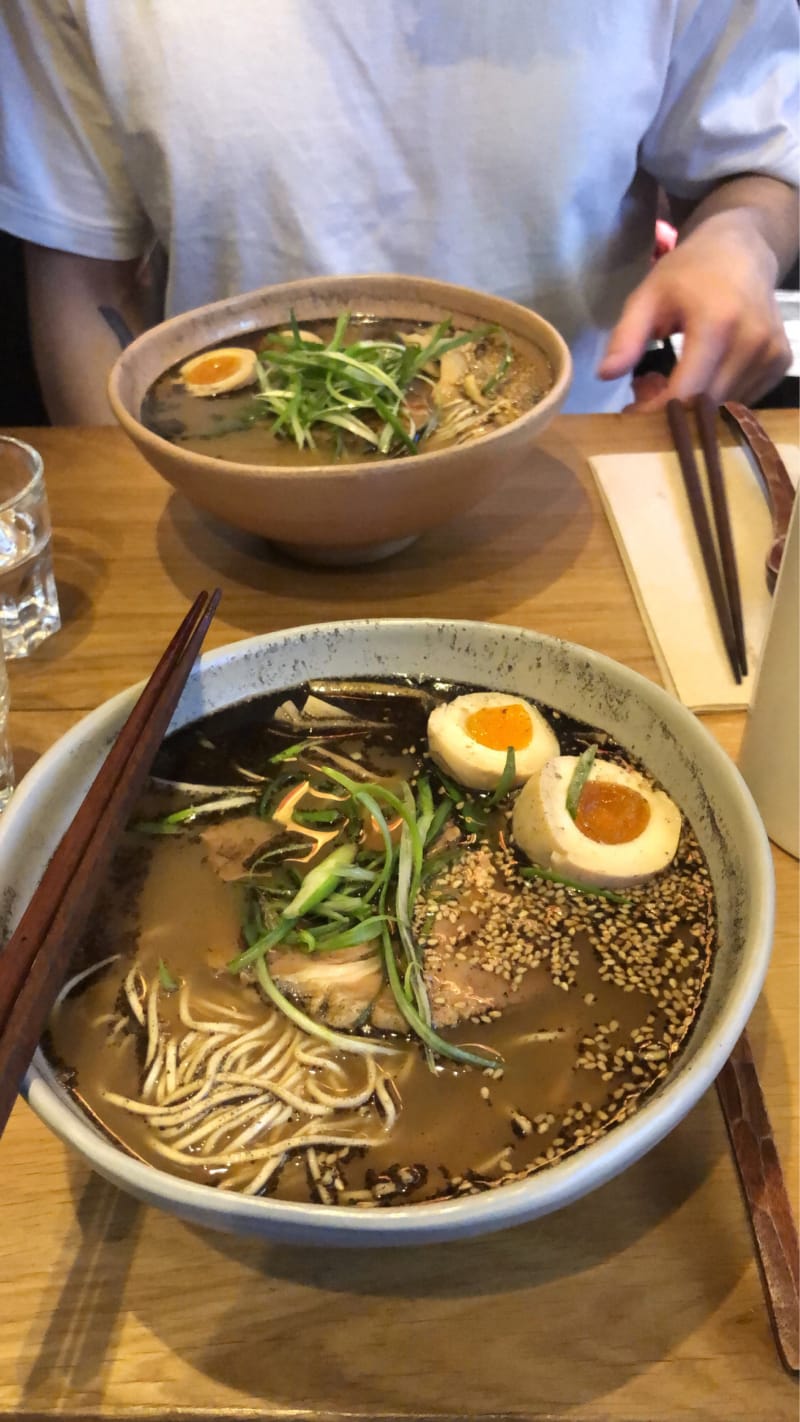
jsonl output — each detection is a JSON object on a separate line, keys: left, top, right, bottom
{"left": 600, "top": 173, "right": 799, "bottom": 410}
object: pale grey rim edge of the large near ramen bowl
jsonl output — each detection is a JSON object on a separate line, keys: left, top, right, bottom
{"left": 10, "top": 617, "right": 774, "bottom": 1244}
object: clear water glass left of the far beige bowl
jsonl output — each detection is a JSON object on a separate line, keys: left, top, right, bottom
{"left": 0, "top": 435, "right": 61, "bottom": 658}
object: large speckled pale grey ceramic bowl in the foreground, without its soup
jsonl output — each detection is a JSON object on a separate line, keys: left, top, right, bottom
{"left": 0, "top": 620, "right": 773, "bottom": 1246}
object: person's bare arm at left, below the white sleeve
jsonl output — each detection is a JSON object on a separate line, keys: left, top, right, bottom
{"left": 24, "top": 242, "right": 148, "bottom": 425}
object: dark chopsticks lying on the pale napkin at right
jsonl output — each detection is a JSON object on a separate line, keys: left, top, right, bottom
{"left": 666, "top": 395, "right": 747, "bottom": 685}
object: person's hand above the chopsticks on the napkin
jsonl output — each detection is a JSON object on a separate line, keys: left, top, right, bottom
{"left": 598, "top": 212, "right": 791, "bottom": 411}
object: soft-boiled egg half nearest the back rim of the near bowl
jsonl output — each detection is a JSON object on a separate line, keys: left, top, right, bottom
{"left": 428, "top": 691, "right": 558, "bottom": 791}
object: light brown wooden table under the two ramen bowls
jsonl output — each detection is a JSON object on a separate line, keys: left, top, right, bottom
{"left": 0, "top": 412, "right": 799, "bottom": 1422}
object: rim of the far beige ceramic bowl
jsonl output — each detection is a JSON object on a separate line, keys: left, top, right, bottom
{"left": 107, "top": 272, "right": 573, "bottom": 481}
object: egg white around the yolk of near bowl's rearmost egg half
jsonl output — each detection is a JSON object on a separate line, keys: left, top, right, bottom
{"left": 428, "top": 691, "right": 558, "bottom": 791}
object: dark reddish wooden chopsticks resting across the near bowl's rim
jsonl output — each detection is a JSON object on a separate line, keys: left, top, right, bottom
{"left": 0, "top": 589, "right": 220, "bottom": 1132}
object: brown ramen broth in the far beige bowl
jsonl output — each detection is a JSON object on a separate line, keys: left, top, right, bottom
{"left": 141, "top": 317, "right": 553, "bottom": 466}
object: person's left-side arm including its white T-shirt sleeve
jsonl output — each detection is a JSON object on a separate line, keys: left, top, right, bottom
{"left": 0, "top": 0, "right": 153, "bottom": 424}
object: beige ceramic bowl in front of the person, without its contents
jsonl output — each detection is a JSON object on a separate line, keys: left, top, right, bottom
{"left": 108, "top": 276, "right": 571, "bottom": 563}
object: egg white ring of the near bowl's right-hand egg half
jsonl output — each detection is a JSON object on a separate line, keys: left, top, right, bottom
{"left": 512, "top": 755, "right": 681, "bottom": 889}
